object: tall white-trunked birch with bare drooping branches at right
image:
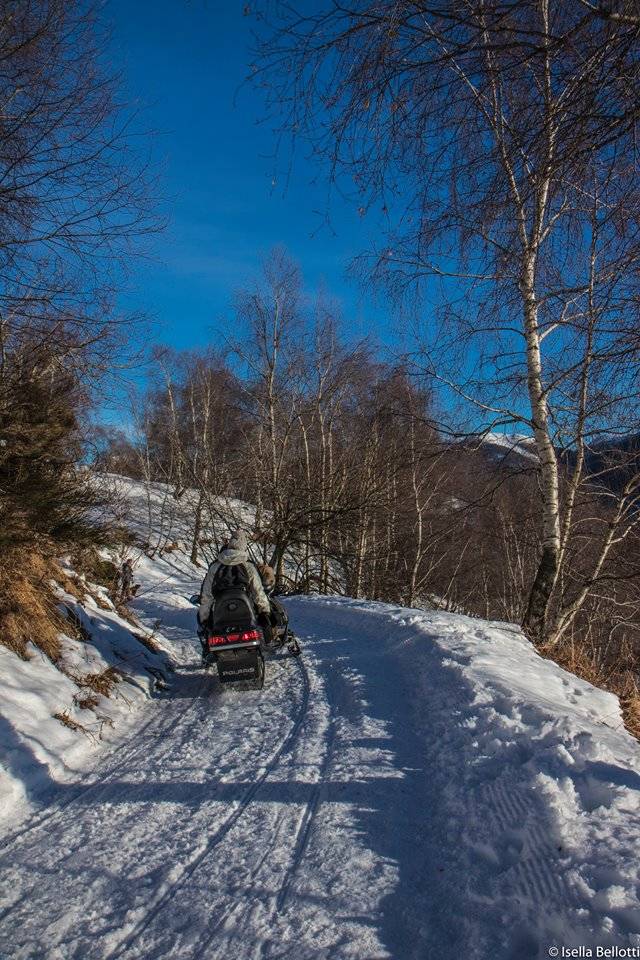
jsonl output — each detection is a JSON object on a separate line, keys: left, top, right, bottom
{"left": 256, "top": 0, "right": 640, "bottom": 643}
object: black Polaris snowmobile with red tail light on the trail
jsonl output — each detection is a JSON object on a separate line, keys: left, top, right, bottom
{"left": 202, "top": 588, "right": 301, "bottom": 690}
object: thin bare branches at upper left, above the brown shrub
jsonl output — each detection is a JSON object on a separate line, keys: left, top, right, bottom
{"left": 0, "top": 0, "right": 158, "bottom": 367}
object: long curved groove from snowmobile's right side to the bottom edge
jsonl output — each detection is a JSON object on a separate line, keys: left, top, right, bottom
{"left": 104, "top": 658, "right": 311, "bottom": 960}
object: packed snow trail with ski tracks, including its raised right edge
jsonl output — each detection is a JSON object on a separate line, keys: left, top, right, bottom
{"left": 0, "top": 561, "right": 640, "bottom": 960}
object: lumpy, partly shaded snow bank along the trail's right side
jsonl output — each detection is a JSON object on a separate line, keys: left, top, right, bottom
{"left": 293, "top": 597, "right": 640, "bottom": 960}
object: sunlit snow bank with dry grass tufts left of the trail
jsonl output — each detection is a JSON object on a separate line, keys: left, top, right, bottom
{"left": 0, "top": 568, "right": 172, "bottom": 824}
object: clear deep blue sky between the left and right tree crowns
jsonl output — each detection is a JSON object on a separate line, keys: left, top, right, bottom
{"left": 106, "top": 0, "right": 390, "bottom": 349}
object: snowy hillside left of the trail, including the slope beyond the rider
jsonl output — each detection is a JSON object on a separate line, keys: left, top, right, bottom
{"left": 0, "top": 474, "right": 254, "bottom": 840}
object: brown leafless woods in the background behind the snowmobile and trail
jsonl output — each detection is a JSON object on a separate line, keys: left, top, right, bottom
{"left": 92, "top": 236, "right": 640, "bottom": 732}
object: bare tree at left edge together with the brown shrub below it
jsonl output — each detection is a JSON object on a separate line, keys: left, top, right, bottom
{"left": 0, "top": 0, "right": 158, "bottom": 551}
